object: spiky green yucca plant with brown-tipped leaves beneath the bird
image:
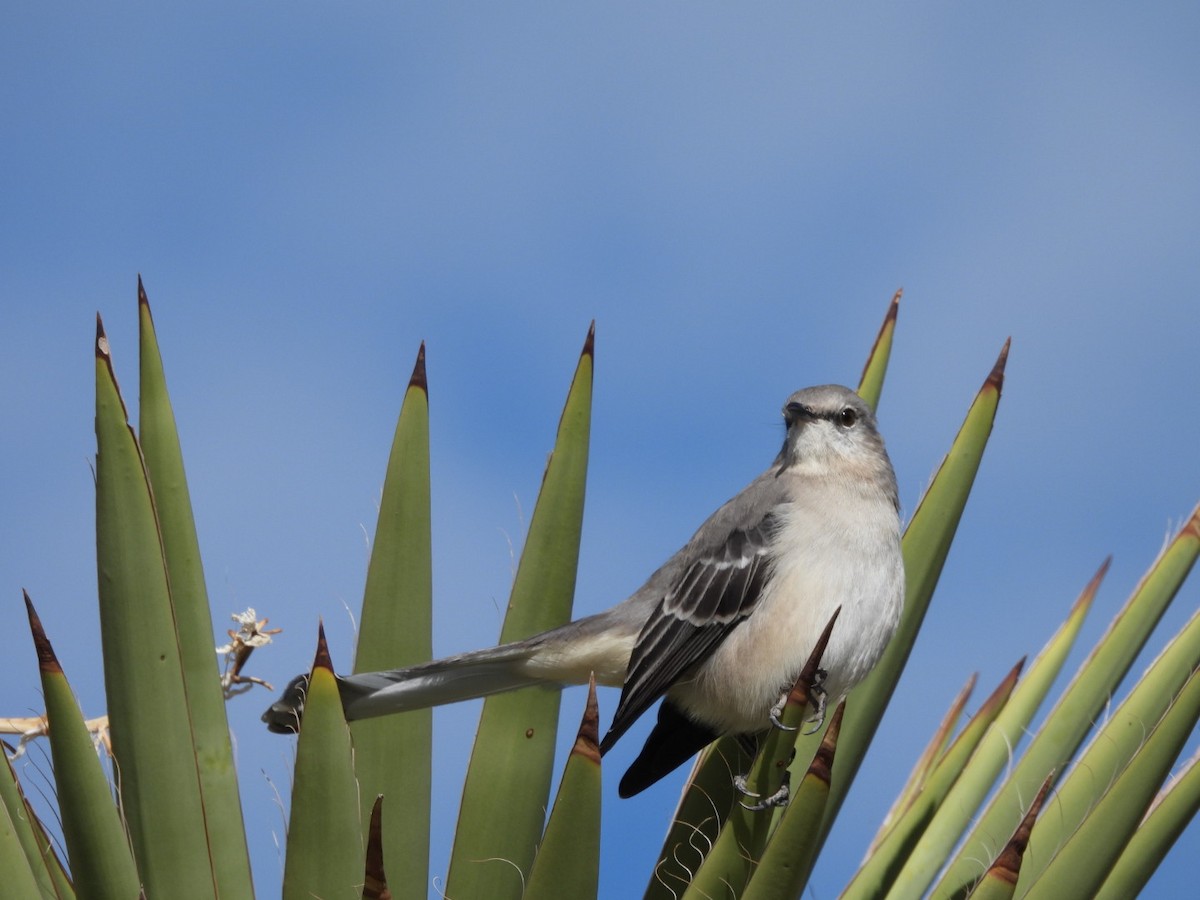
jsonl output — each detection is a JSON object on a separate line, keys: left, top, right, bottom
{"left": 0, "top": 282, "right": 1200, "bottom": 900}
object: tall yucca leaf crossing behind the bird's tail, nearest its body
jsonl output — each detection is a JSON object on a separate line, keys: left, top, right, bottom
{"left": 446, "top": 328, "right": 594, "bottom": 900}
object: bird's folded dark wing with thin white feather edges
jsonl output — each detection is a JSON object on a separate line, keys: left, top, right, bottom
{"left": 601, "top": 512, "right": 776, "bottom": 750}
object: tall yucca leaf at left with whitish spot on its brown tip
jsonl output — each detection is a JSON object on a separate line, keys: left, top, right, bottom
{"left": 96, "top": 317, "right": 221, "bottom": 896}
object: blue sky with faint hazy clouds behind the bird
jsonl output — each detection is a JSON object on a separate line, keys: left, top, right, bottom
{"left": 0, "top": 2, "right": 1200, "bottom": 898}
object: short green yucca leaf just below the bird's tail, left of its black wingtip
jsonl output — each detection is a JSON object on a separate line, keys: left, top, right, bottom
{"left": 522, "top": 678, "right": 600, "bottom": 900}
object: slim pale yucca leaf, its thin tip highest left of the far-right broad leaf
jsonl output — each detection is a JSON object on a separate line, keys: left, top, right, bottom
{"left": 893, "top": 559, "right": 1111, "bottom": 898}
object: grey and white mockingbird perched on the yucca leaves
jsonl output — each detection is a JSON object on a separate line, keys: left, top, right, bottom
{"left": 263, "top": 385, "right": 904, "bottom": 797}
